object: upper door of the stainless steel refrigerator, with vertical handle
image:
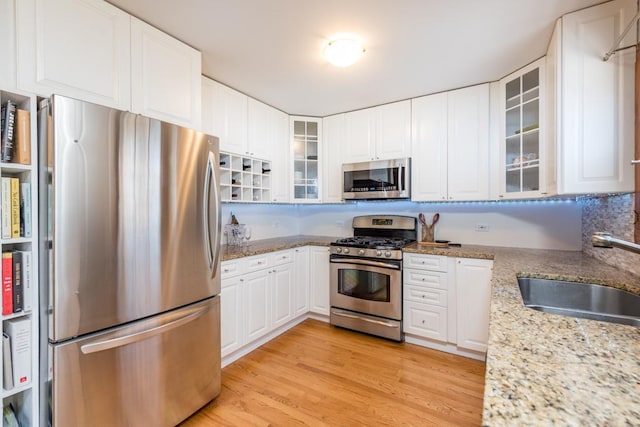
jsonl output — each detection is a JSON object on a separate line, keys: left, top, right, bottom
{"left": 41, "top": 96, "right": 220, "bottom": 342}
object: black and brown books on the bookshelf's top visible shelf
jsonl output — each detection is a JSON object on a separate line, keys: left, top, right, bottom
{"left": 0, "top": 100, "right": 31, "bottom": 165}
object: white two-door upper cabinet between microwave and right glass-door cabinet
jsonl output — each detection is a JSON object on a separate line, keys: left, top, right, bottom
{"left": 411, "top": 84, "right": 489, "bottom": 201}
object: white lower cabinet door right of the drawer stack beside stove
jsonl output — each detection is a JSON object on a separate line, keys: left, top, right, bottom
{"left": 456, "top": 258, "right": 493, "bottom": 352}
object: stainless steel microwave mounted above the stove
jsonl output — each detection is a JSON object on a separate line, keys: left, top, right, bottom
{"left": 342, "top": 158, "right": 411, "bottom": 200}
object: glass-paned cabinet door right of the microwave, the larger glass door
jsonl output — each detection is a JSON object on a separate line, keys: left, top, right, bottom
{"left": 502, "top": 67, "right": 541, "bottom": 193}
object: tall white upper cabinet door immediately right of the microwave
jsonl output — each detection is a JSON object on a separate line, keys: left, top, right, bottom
{"left": 411, "top": 92, "right": 448, "bottom": 201}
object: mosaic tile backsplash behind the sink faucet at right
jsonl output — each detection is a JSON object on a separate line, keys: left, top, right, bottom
{"left": 580, "top": 194, "right": 640, "bottom": 276}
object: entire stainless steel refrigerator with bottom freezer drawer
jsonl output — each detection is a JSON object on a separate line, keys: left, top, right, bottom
{"left": 38, "top": 95, "right": 220, "bottom": 427}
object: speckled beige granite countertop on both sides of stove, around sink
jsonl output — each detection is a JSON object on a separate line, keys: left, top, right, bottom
{"left": 222, "top": 236, "right": 640, "bottom": 426}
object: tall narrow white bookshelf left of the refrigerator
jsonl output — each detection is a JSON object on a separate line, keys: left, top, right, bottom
{"left": 0, "top": 88, "right": 39, "bottom": 426}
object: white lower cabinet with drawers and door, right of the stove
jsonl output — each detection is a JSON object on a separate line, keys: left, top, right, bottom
{"left": 403, "top": 253, "right": 493, "bottom": 359}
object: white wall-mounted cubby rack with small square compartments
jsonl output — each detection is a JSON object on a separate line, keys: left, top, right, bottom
{"left": 220, "top": 152, "right": 271, "bottom": 203}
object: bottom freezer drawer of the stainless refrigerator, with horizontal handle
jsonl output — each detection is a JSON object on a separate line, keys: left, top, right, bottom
{"left": 48, "top": 296, "right": 220, "bottom": 427}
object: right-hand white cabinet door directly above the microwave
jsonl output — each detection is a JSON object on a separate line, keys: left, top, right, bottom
{"left": 375, "top": 100, "right": 411, "bottom": 160}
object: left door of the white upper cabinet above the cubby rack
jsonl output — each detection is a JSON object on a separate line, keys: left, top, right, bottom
{"left": 202, "top": 77, "right": 248, "bottom": 155}
